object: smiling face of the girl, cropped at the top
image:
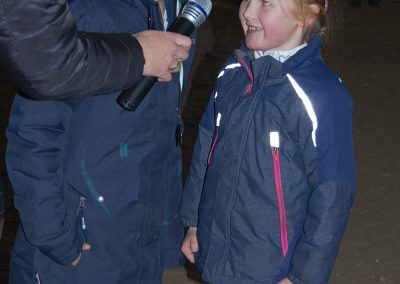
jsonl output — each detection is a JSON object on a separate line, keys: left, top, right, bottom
{"left": 239, "top": 0, "right": 303, "bottom": 51}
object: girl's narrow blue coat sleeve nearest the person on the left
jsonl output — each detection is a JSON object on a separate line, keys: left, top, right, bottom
{"left": 180, "top": 96, "right": 214, "bottom": 227}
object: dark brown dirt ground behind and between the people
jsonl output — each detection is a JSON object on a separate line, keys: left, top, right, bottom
{"left": 0, "top": 0, "right": 400, "bottom": 284}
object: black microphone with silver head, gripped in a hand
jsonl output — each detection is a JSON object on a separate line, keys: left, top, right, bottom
{"left": 117, "top": 0, "right": 212, "bottom": 111}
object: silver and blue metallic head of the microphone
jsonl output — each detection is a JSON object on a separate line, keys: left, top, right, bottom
{"left": 179, "top": 0, "right": 212, "bottom": 28}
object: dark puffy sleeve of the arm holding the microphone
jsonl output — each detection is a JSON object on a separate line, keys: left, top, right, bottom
{"left": 0, "top": 0, "right": 144, "bottom": 99}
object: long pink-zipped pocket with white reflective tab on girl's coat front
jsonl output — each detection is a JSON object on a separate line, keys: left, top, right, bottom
{"left": 269, "top": 131, "right": 288, "bottom": 256}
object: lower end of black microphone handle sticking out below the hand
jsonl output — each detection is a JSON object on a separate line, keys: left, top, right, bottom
{"left": 117, "top": 76, "right": 158, "bottom": 111}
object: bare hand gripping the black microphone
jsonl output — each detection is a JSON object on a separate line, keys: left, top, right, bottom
{"left": 133, "top": 31, "right": 192, "bottom": 81}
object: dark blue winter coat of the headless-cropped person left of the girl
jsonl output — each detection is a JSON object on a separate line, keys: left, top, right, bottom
{"left": 6, "top": 0, "right": 194, "bottom": 284}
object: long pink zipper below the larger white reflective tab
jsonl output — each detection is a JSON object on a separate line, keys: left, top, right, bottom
{"left": 271, "top": 147, "right": 288, "bottom": 256}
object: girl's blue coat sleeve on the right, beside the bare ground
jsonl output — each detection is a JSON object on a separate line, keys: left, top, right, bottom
{"left": 289, "top": 90, "right": 355, "bottom": 284}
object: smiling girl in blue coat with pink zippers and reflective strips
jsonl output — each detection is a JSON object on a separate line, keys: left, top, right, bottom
{"left": 181, "top": 0, "right": 355, "bottom": 284}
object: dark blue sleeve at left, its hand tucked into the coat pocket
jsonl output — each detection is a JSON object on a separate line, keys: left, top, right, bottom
{"left": 6, "top": 96, "right": 83, "bottom": 265}
